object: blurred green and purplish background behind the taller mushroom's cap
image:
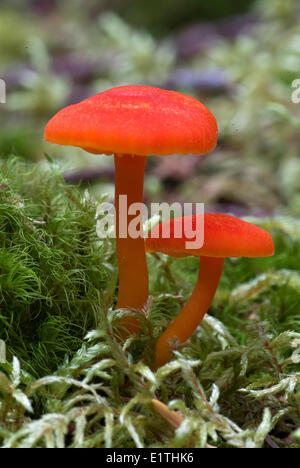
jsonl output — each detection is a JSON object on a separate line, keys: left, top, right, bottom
{"left": 0, "top": 0, "right": 300, "bottom": 216}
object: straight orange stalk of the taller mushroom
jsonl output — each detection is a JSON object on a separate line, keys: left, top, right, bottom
{"left": 115, "top": 155, "right": 148, "bottom": 332}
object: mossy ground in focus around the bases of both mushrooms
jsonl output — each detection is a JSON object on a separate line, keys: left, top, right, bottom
{"left": 0, "top": 158, "right": 300, "bottom": 448}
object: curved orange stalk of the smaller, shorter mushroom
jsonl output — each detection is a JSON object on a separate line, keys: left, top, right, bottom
{"left": 155, "top": 257, "right": 224, "bottom": 369}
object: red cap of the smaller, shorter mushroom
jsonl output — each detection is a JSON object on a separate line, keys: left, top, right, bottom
{"left": 146, "top": 213, "right": 274, "bottom": 258}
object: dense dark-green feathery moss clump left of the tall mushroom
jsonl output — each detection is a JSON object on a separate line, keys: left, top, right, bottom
{"left": 0, "top": 160, "right": 114, "bottom": 376}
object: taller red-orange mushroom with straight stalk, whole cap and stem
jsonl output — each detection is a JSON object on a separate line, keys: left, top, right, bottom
{"left": 45, "top": 86, "right": 218, "bottom": 330}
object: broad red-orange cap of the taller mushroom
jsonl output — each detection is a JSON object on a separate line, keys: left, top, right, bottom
{"left": 45, "top": 86, "right": 218, "bottom": 156}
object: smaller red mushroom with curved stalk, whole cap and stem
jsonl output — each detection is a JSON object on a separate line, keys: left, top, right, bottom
{"left": 146, "top": 213, "right": 274, "bottom": 369}
